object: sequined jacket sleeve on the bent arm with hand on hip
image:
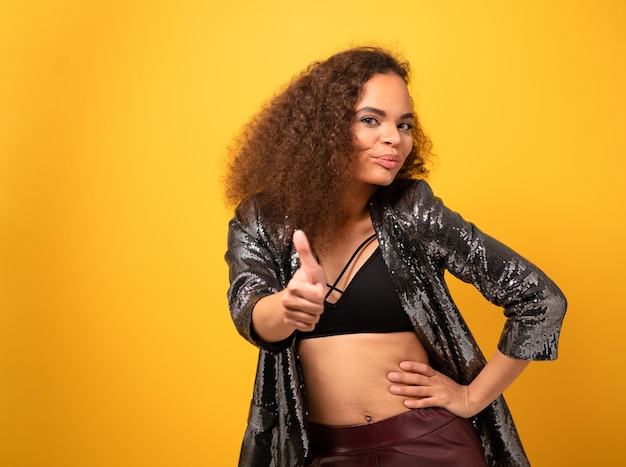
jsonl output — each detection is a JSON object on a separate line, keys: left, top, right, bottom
{"left": 412, "top": 182, "right": 567, "bottom": 360}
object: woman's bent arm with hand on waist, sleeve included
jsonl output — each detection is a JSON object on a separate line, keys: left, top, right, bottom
{"left": 382, "top": 182, "right": 567, "bottom": 417}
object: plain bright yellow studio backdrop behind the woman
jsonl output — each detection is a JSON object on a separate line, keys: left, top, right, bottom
{"left": 0, "top": 0, "right": 626, "bottom": 467}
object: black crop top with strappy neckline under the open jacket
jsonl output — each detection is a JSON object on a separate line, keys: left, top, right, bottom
{"left": 298, "top": 245, "right": 413, "bottom": 339}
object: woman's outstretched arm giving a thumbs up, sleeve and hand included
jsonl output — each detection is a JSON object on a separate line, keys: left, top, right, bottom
{"left": 226, "top": 219, "right": 326, "bottom": 351}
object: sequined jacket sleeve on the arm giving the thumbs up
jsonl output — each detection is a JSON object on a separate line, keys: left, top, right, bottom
{"left": 225, "top": 202, "right": 292, "bottom": 352}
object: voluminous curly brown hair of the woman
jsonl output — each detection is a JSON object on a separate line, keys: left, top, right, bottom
{"left": 224, "top": 47, "right": 432, "bottom": 249}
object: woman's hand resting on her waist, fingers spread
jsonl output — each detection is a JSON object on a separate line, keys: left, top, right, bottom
{"left": 387, "top": 361, "right": 484, "bottom": 418}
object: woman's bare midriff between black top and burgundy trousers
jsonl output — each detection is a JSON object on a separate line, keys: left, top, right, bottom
{"left": 298, "top": 332, "right": 428, "bottom": 426}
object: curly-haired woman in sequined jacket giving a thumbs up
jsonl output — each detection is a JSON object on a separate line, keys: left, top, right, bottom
{"left": 226, "top": 44, "right": 566, "bottom": 467}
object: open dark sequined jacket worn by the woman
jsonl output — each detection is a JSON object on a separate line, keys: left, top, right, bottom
{"left": 226, "top": 179, "right": 566, "bottom": 467}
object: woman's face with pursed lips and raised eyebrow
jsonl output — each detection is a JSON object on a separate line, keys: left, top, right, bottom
{"left": 351, "top": 73, "right": 414, "bottom": 186}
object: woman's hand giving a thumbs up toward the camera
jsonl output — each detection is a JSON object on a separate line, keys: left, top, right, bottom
{"left": 282, "top": 230, "right": 326, "bottom": 332}
